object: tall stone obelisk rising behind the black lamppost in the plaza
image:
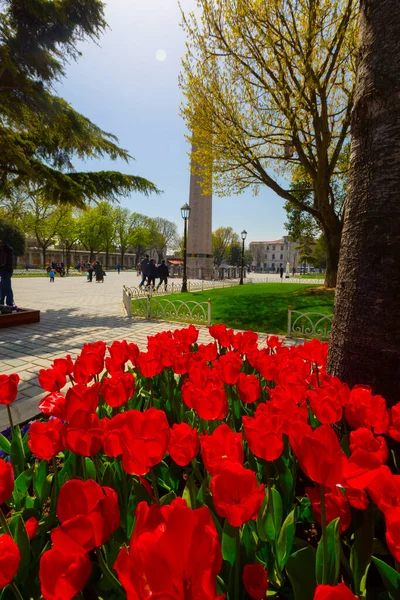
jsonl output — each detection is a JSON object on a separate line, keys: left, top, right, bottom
{"left": 187, "top": 146, "right": 214, "bottom": 279}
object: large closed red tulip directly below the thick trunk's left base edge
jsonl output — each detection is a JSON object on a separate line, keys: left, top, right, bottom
{"left": 290, "top": 425, "right": 347, "bottom": 487}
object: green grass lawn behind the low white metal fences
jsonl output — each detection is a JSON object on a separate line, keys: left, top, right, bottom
{"left": 160, "top": 283, "right": 334, "bottom": 334}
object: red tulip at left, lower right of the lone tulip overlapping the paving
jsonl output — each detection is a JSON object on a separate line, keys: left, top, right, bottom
{"left": 28, "top": 419, "right": 64, "bottom": 460}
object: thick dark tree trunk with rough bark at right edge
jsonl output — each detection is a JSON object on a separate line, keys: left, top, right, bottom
{"left": 328, "top": 0, "right": 400, "bottom": 404}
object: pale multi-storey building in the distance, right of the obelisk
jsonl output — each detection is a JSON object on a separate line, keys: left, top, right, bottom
{"left": 250, "top": 236, "right": 299, "bottom": 273}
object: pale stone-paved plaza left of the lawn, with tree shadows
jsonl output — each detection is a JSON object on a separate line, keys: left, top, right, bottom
{"left": 0, "top": 271, "right": 282, "bottom": 431}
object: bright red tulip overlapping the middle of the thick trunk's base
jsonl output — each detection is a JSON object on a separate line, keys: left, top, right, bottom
{"left": 345, "top": 386, "right": 389, "bottom": 434}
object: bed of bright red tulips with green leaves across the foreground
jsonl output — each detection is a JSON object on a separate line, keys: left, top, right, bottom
{"left": 0, "top": 325, "right": 400, "bottom": 600}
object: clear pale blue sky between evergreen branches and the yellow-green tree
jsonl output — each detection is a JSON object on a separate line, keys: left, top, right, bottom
{"left": 58, "top": 0, "right": 285, "bottom": 241}
